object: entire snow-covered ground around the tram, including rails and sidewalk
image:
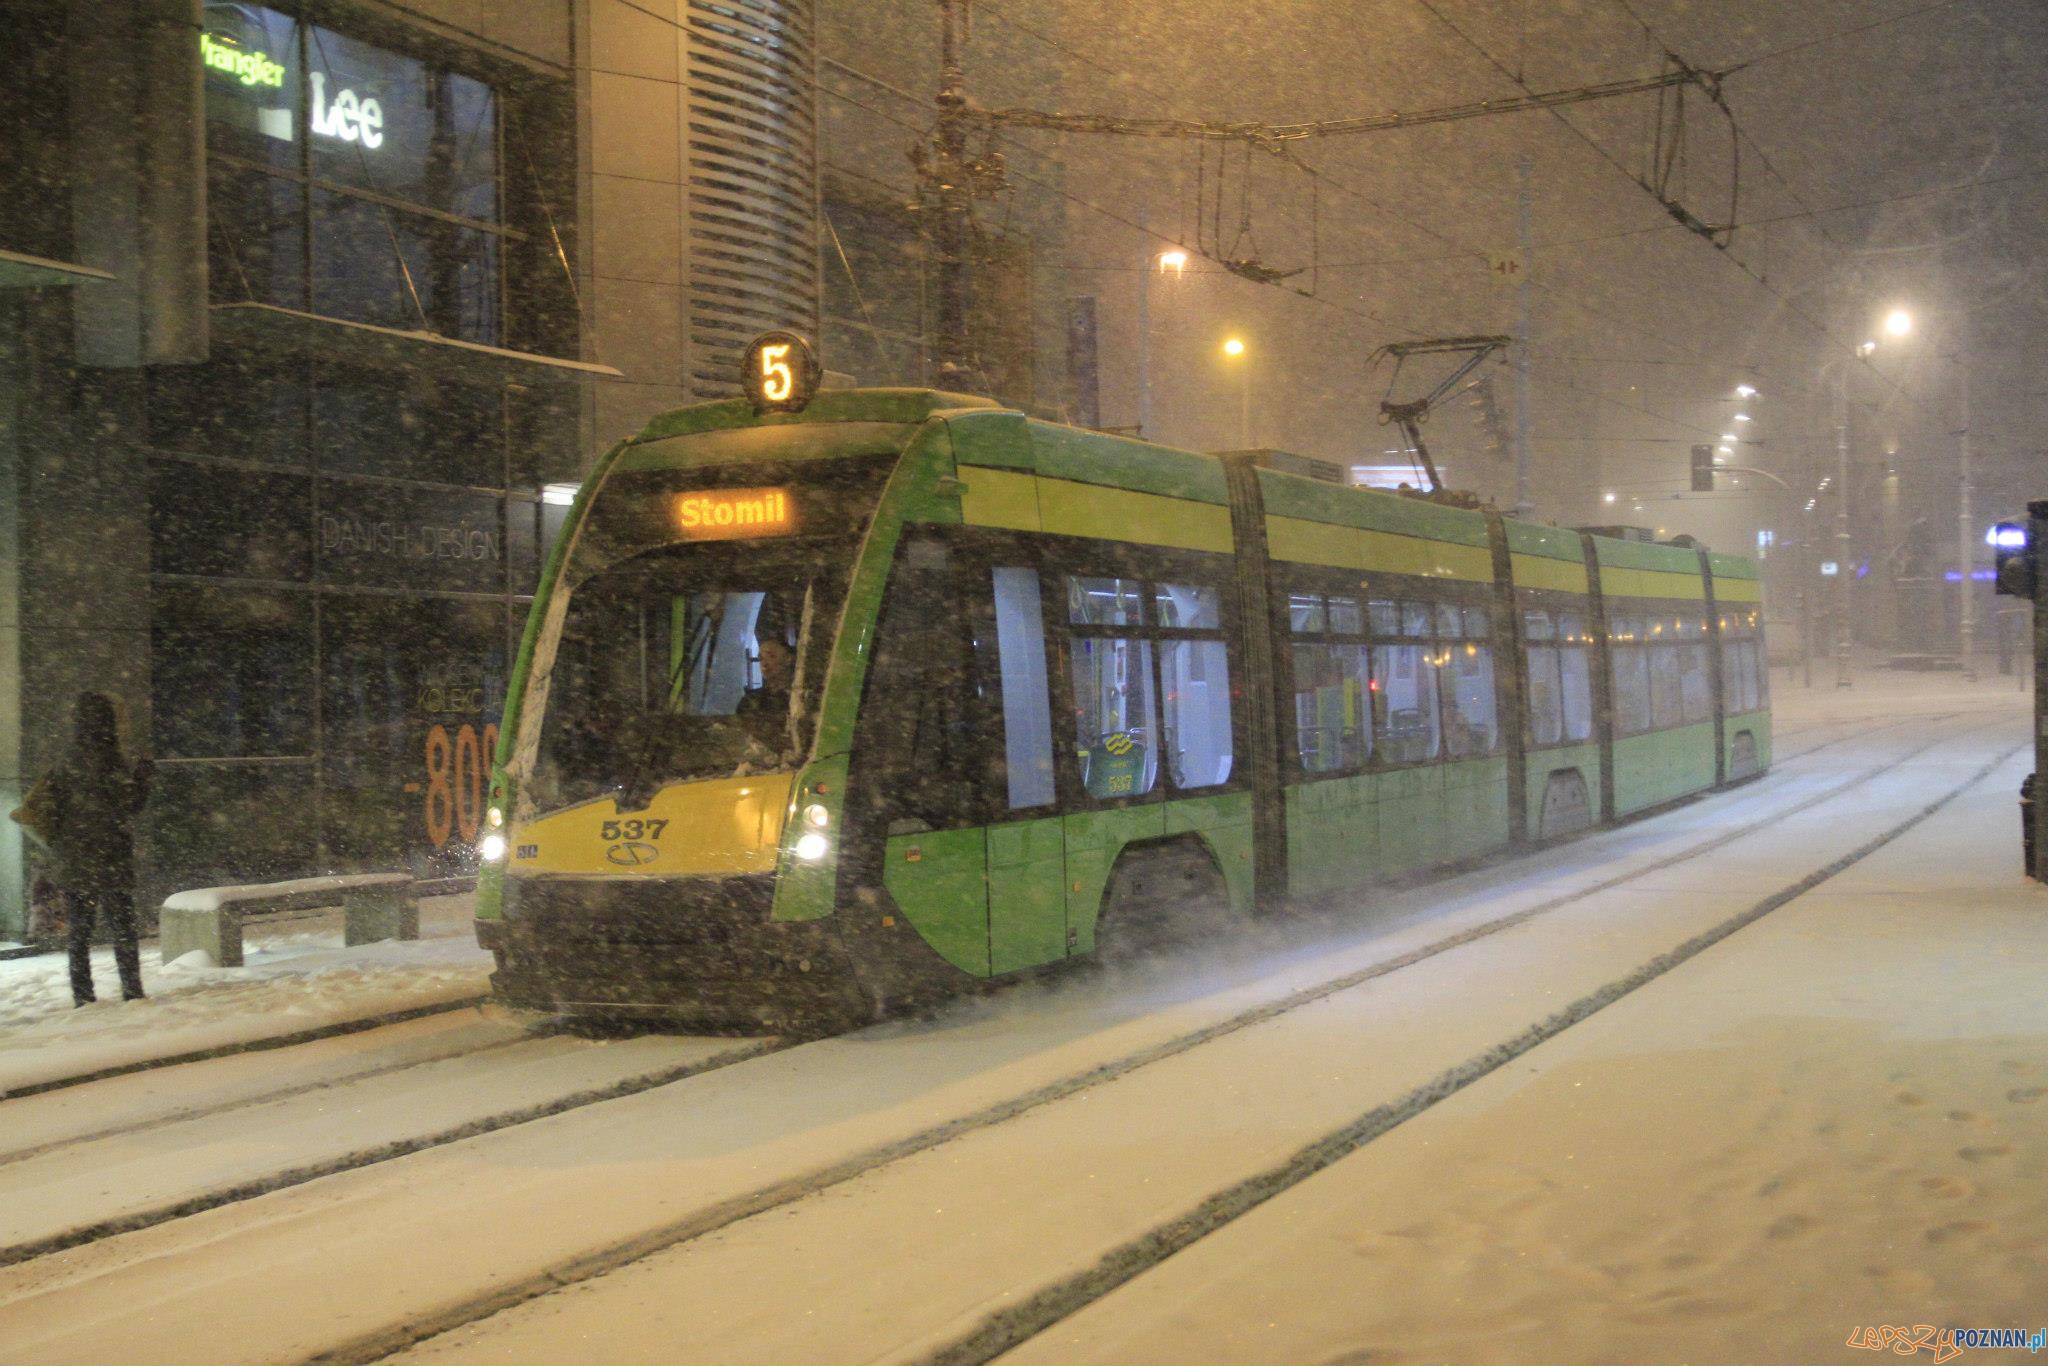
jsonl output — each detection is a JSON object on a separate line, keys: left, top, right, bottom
{"left": 0, "top": 670, "right": 2048, "bottom": 1366}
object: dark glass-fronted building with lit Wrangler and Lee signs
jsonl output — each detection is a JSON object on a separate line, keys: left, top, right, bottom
{"left": 0, "top": 0, "right": 856, "bottom": 938}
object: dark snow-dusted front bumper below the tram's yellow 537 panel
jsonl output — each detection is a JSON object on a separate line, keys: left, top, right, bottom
{"left": 477, "top": 877, "right": 872, "bottom": 1028}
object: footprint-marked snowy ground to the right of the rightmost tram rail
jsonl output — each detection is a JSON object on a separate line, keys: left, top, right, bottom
{"left": 1001, "top": 758, "right": 2048, "bottom": 1366}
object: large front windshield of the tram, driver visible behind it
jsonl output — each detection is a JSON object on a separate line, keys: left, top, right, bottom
{"left": 532, "top": 541, "right": 852, "bottom": 807}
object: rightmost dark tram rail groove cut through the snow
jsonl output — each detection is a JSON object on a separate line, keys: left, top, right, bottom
{"left": 913, "top": 743, "right": 2028, "bottom": 1366}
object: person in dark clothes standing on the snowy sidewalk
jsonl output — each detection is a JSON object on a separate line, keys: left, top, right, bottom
{"left": 14, "top": 692, "right": 152, "bottom": 1006}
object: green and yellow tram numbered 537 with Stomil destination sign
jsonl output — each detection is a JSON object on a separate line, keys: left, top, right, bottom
{"left": 477, "top": 348, "right": 1769, "bottom": 1024}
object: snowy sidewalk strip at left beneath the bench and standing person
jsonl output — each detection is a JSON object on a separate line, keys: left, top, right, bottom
{"left": 0, "top": 893, "right": 492, "bottom": 1094}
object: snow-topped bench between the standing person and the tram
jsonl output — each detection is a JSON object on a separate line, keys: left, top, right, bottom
{"left": 158, "top": 872, "right": 420, "bottom": 967}
